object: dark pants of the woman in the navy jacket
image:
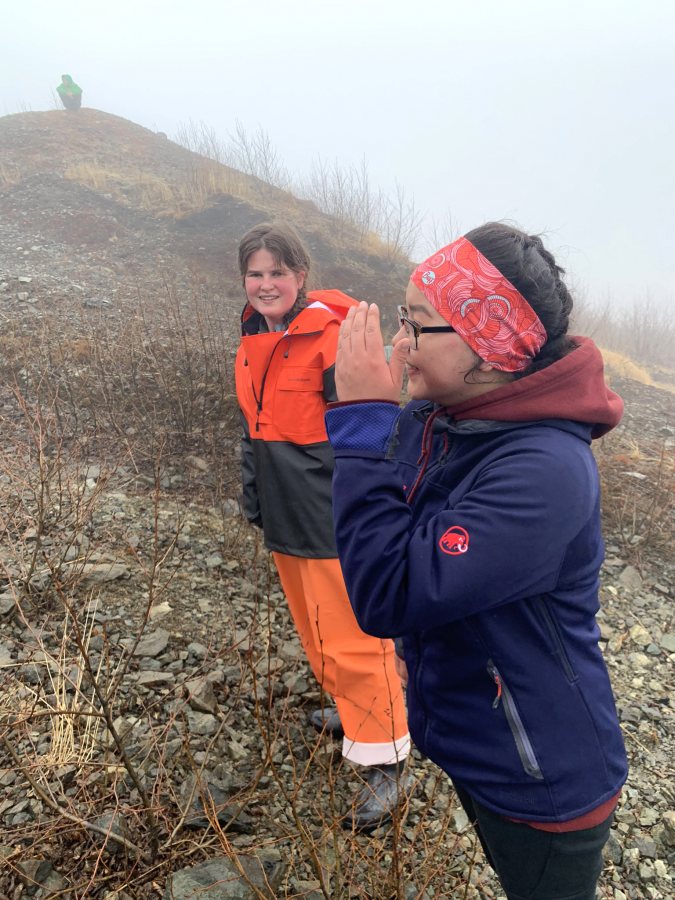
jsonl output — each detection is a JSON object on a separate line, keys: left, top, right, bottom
{"left": 455, "top": 786, "right": 613, "bottom": 900}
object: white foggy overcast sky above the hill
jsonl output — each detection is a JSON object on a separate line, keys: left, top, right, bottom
{"left": 0, "top": 0, "right": 675, "bottom": 309}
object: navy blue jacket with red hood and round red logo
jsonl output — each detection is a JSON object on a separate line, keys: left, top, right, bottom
{"left": 326, "top": 340, "right": 627, "bottom": 822}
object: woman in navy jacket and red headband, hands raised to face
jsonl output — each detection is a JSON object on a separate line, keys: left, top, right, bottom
{"left": 326, "top": 223, "right": 627, "bottom": 900}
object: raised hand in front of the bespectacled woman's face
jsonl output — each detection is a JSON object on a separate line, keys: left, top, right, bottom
{"left": 335, "top": 302, "right": 410, "bottom": 403}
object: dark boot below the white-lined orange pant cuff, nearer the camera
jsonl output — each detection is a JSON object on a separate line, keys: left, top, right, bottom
{"left": 344, "top": 760, "right": 413, "bottom": 831}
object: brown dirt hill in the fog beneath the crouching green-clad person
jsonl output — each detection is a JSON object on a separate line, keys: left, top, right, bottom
{"left": 0, "top": 109, "right": 408, "bottom": 306}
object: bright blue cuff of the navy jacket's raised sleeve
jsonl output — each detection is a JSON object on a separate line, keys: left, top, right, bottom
{"left": 326, "top": 400, "right": 401, "bottom": 453}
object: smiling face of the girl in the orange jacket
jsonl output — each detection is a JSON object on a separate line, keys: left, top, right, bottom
{"left": 244, "top": 249, "right": 305, "bottom": 331}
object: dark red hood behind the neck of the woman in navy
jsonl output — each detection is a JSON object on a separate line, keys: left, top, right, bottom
{"left": 446, "top": 337, "right": 623, "bottom": 438}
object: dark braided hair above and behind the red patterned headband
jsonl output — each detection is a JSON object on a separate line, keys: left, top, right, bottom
{"left": 464, "top": 222, "right": 576, "bottom": 378}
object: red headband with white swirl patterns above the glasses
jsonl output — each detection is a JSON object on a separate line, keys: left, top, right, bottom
{"left": 410, "top": 238, "right": 546, "bottom": 372}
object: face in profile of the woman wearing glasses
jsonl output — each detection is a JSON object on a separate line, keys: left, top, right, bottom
{"left": 394, "top": 282, "right": 511, "bottom": 406}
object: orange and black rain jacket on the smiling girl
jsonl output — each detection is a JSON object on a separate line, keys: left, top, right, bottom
{"left": 235, "top": 290, "right": 358, "bottom": 559}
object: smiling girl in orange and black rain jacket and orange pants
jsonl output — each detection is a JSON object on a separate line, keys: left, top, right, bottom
{"left": 235, "top": 224, "right": 410, "bottom": 829}
